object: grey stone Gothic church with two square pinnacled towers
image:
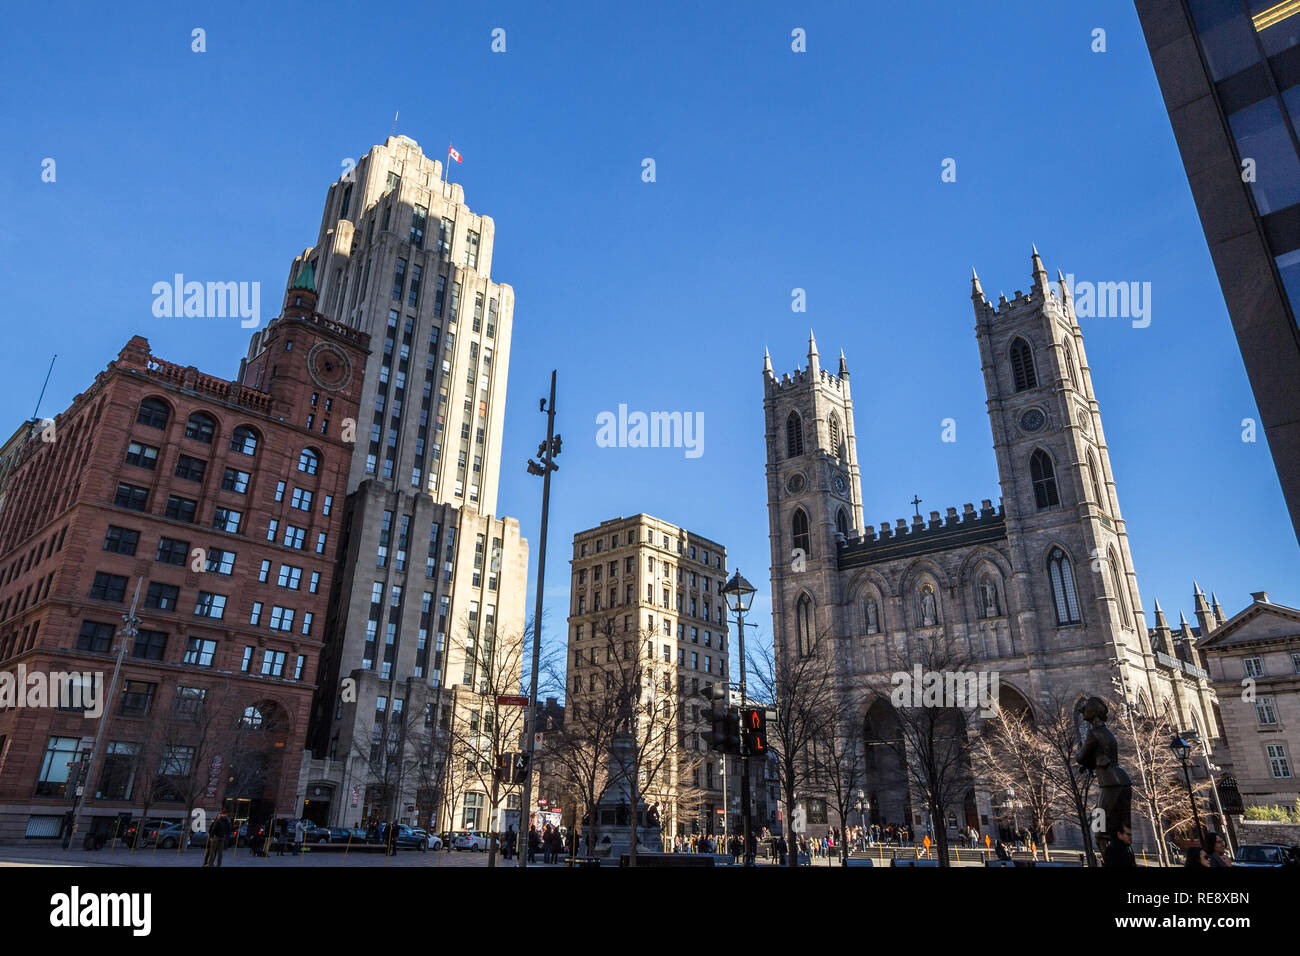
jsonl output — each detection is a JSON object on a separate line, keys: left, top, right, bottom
{"left": 763, "top": 248, "right": 1219, "bottom": 844}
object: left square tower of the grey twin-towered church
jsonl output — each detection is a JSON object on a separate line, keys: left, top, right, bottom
{"left": 763, "top": 333, "right": 862, "bottom": 654}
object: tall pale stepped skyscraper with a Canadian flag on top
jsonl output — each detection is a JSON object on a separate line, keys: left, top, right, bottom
{"left": 250, "top": 135, "right": 528, "bottom": 829}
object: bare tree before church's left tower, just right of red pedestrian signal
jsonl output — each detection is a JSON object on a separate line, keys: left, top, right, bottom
{"left": 745, "top": 639, "right": 837, "bottom": 866}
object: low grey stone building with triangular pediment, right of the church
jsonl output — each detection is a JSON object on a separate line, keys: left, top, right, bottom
{"left": 1196, "top": 591, "right": 1300, "bottom": 813}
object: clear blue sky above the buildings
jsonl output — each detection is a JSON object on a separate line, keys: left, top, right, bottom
{"left": 0, "top": 0, "right": 1300, "bottom": 665}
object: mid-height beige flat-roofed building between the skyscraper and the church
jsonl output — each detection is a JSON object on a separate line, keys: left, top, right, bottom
{"left": 566, "top": 514, "right": 740, "bottom": 839}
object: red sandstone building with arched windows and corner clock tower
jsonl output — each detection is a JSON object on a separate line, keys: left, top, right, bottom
{"left": 0, "top": 274, "right": 369, "bottom": 843}
